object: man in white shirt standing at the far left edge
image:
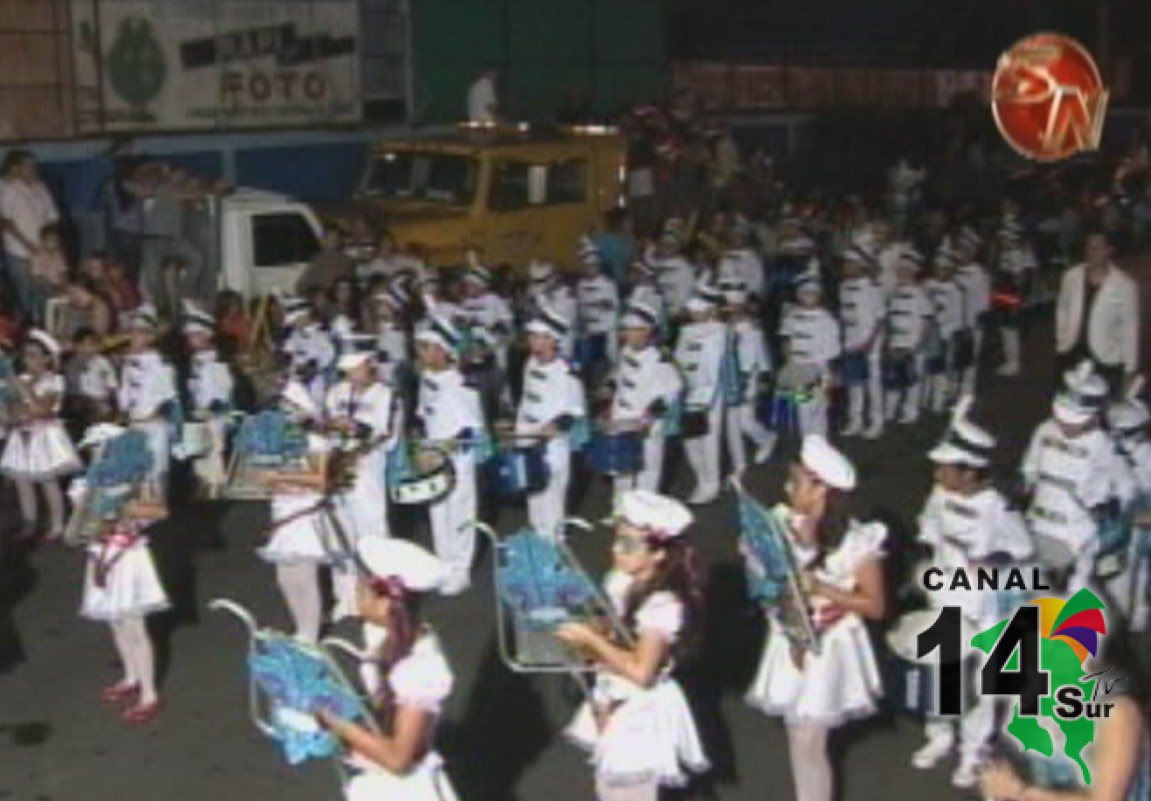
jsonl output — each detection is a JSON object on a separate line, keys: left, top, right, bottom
{"left": 0, "top": 150, "right": 60, "bottom": 313}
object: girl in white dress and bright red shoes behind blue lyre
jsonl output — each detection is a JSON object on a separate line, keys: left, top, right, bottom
{"left": 73, "top": 424, "right": 169, "bottom": 725}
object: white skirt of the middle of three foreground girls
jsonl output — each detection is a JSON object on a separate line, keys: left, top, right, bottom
{"left": 565, "top": 678, "right": 710, "bottom": 787}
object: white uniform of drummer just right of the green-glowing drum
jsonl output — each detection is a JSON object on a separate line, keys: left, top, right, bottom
{"left": 839, "top": 276, "right": 886, "bottom": 435}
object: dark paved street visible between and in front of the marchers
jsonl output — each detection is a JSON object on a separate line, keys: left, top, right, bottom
{"left": 0, "top": 310, "right": 1146, "bottom": 801}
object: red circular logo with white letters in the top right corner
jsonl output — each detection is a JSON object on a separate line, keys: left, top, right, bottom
{"left": 991, "top": 33, "right": 1107, "bottom": 161}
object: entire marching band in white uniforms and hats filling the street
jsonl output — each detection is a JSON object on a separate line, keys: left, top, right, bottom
{"left": 0, "top": 215, "right": 1151, "bottom": 801}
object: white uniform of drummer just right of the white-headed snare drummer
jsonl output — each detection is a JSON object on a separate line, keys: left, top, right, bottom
{"left": 516, "top": 357, "right": 587, "bottom": 536}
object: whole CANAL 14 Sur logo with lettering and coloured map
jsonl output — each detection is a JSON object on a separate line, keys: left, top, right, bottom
{"left": 916, "top": 569, "right": 1123, "bottom": 784}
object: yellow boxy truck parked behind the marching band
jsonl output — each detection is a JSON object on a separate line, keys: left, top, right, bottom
{"left": 356, "top": 124, "right": 626, "bottom": 267}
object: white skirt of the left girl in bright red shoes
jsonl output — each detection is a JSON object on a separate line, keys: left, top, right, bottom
{"left": 79, "top": 539, "right": 170, "bottom": 621}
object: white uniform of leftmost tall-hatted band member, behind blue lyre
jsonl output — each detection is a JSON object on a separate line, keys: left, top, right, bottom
{"left": 117, "top": 350, "right": 180, "bottom": 501}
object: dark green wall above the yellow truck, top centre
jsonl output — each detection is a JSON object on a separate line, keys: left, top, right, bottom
{"left": 412, "top": 0, "right": 668, "bottom": 122}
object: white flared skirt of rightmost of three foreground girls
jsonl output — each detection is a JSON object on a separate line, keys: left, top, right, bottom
{"left": 746, "top": 617, "right": 883, "bottom": 727}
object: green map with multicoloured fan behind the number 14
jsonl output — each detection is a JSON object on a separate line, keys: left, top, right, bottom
{"left": 971, "top": 589, "right": 1113, "bottom": 784}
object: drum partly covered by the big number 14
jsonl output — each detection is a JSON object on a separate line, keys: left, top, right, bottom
{"left": 886, "top": 609, "right": 975, "bottom": 719}
